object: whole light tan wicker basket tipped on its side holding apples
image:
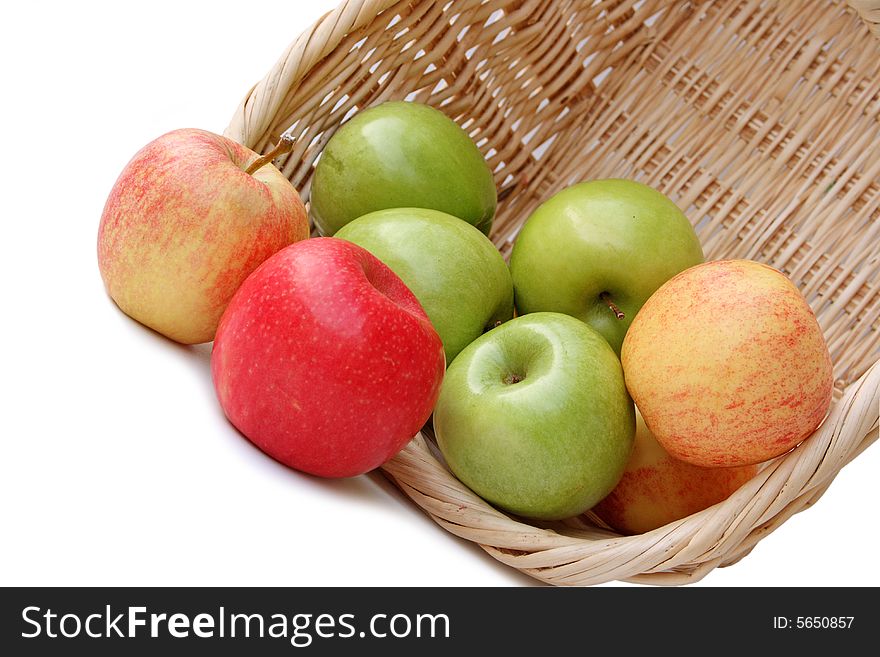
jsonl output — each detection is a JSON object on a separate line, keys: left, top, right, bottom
{"left": 226, "top": 0, "right": 880, "bottom": 585}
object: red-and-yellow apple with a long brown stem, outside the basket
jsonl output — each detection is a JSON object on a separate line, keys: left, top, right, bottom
{"left": 98, "top": 129, "right": 309, "bottom": 344}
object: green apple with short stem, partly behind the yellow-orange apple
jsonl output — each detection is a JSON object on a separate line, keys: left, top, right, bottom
{"left": 510, "top": 179, "right": 703, "bottom": 355}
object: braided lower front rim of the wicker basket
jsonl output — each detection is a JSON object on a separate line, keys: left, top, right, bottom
{"left": 382, "top": 360, "right": 880, "bottom": 585}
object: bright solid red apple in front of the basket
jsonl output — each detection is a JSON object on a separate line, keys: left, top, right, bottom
{"left": 211, "top": 237, "right": 446, "bottom": 477}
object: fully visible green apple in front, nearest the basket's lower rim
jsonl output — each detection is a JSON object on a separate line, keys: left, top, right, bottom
{"left": 434, "top": 313, "right": 635, "bottom": 520}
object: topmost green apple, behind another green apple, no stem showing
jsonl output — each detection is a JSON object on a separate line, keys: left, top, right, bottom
{"left": 310, "top": 102, "right": 497, "bottom": 235}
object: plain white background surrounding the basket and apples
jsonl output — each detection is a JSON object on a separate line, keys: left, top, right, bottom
{"left": 0, "top": 0, "right": 880, "bottom": 584}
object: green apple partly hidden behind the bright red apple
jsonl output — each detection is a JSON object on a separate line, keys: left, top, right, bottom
{"left": 336, "top": 208, "right": 513, "bottom": 363}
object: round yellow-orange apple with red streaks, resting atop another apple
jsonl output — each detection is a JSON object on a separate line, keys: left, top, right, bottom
{"left": 622, "top": 260, "right": 833, "bottom": 467}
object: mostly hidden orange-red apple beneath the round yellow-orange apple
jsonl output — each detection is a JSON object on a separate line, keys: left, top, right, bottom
{"left": 593, "top": 408, "right": 758, "bottom": 534}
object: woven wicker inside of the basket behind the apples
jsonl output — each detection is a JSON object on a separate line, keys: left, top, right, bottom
{"left": 242, "top": 0, "right": 880, "bottom": 391}
